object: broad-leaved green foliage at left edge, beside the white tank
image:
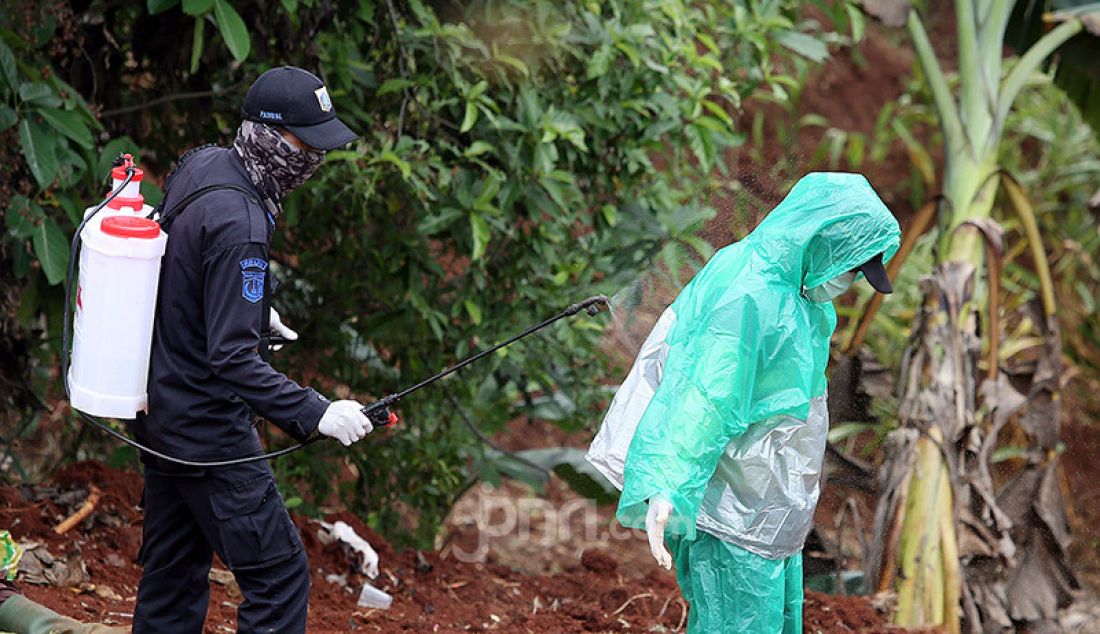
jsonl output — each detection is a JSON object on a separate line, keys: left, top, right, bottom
{"left": 0, "top": 12, "right": 117, "bottom": 420}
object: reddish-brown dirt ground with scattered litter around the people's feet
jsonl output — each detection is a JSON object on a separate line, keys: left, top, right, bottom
{"left": 0, "top": 462, "right": 928, "bottom": 633}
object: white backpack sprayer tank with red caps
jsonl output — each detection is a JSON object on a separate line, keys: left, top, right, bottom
{"left": 68, "top": 154, "right": 168, "bottom": 418}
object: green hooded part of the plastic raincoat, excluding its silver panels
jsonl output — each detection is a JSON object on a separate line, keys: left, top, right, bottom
{"left": 618, "top": 173, "right": 901, "bottom": 536}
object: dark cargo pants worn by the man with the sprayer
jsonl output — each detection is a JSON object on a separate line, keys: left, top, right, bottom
{"left": 133, "top": 457, "right": 309, "bottom": 634}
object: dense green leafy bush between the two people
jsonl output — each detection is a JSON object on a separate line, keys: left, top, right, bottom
{"left": 285, "top": 1, "right": 827, "bottom": 540}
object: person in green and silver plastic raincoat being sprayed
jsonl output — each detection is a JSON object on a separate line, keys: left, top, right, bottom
{"left": 587, "top": 173, "right": 901, "bottom": 634}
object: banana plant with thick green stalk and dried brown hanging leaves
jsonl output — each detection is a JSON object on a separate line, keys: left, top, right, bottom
{"left": 864, "top": 0, "right": 1100, "bottom": 633}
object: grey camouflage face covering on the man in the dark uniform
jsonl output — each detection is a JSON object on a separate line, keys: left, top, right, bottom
{"left": 233, "top": 121, "right": 325, "bottom": 205}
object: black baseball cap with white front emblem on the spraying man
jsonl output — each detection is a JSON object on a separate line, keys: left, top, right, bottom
{"left": 241, "top": 66, "right": 359, "bottom": 150}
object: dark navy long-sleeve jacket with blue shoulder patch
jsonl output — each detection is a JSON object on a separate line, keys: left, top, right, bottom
{"left": 133, "top": 147, "right": 329, "bottom": 460}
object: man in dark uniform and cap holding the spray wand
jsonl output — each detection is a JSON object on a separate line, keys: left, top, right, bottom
{"left": 133, "top": 66, "right": 372, "bottom": 634}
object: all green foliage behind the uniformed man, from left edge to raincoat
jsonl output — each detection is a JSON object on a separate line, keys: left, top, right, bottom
{"left": 0, "top": 0, "right": 850, "bottom": 546}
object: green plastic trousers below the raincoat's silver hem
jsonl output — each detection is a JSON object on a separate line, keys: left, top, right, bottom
{"left": 668, "top": 532, "right": 802, "bottom": 634}
